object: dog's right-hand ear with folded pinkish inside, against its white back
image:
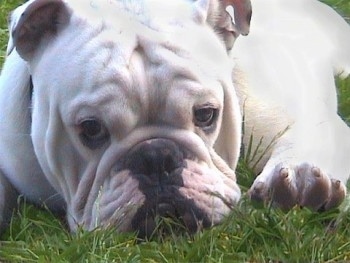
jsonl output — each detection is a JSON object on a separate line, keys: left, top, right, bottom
{"left": 195, "top": 0, "right": 252, "bottom": 50}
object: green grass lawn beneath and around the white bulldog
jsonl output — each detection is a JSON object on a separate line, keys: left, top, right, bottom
{"left": 0, "top": 0, "right": 350, "bottom": 262}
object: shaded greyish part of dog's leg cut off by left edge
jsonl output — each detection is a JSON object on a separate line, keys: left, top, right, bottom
{"left": 0, "top": 171, "right": 18, "bottom": 234}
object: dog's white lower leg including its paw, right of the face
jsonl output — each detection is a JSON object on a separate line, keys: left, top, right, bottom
{"left": 249, "top": 116, "right": 350, "bottom": 210}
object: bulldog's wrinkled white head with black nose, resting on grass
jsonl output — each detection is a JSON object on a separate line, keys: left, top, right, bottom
{"left": 12, "top": 0, "right": 250, "bottom": 234}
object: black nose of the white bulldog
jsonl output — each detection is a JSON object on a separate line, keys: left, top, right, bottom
{"left": 125, "top": 139, "right": 184, "bottom": 184}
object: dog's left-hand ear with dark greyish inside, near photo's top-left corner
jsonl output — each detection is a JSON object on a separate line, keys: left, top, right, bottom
{"left": 7, "top": 0, "right": 70, "bottom": 60}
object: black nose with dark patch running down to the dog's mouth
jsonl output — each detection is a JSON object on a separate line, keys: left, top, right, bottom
{"left": 117, "top": 139, "right": 211, "bottom": 236}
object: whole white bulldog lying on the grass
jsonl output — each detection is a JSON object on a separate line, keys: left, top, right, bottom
{"left": 0, "top": 0, "right": 350, "bottom": 236}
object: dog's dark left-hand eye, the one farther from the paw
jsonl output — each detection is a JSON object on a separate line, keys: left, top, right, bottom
{"left": 80, "top": 119, "right": 109, "bottom": 149}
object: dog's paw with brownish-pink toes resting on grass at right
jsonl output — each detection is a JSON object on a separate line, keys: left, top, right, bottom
{"left": 248, "top": 163, "right": 346, "bottom": 210}
